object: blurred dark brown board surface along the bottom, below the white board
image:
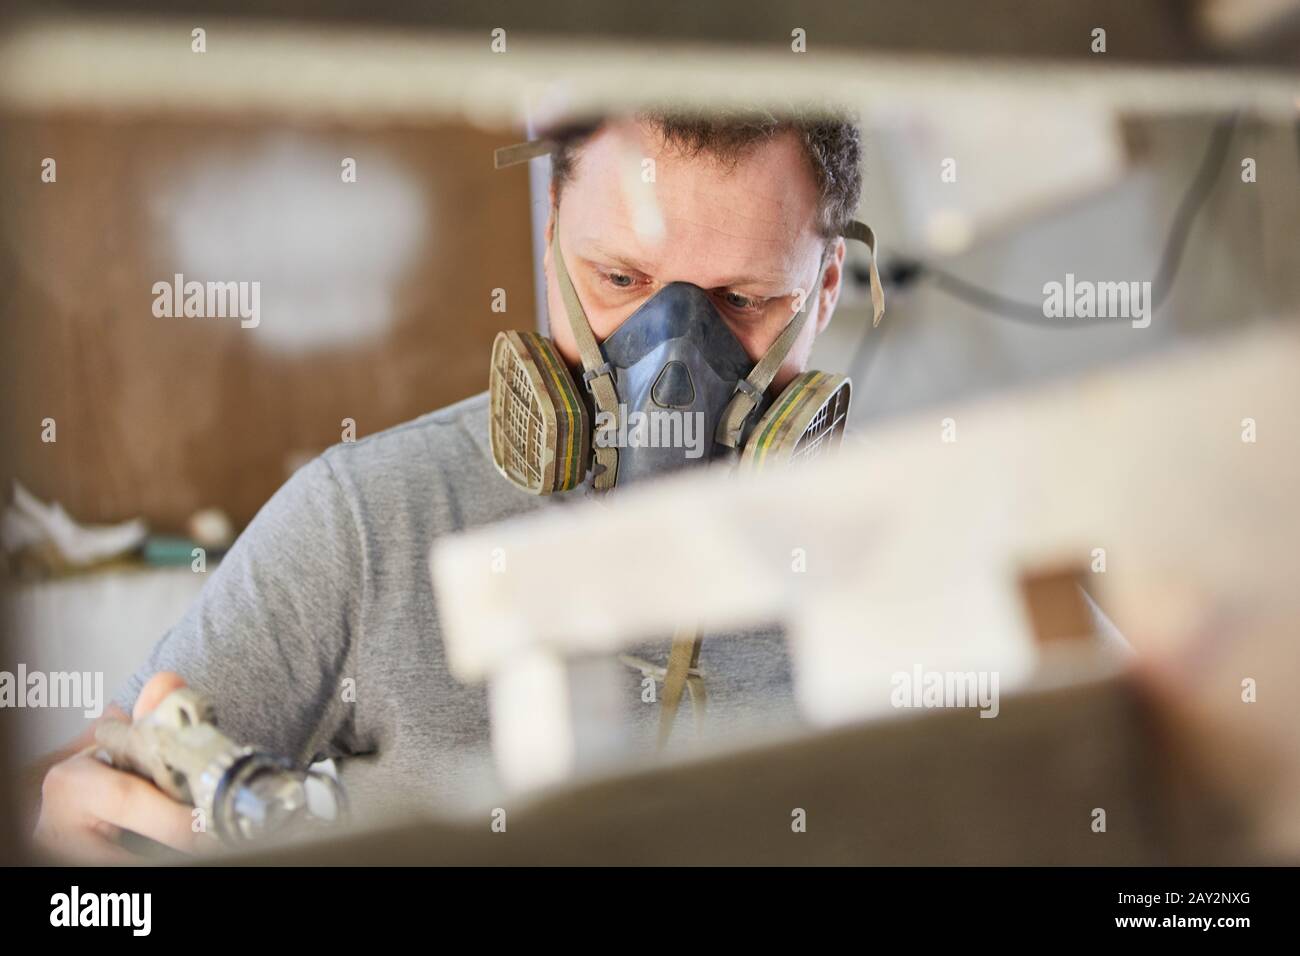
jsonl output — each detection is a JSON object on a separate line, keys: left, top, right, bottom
{"left": 234, "top": 680, "right": 1262, "bottom": 866}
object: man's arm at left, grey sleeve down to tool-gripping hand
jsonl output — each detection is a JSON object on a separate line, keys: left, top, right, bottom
{"left": 27, "top": 453, "right": 365, "bottom": 862}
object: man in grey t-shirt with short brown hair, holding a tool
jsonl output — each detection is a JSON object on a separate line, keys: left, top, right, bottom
{"left": 27, "top": 116, "right": 861, "bottom": 861}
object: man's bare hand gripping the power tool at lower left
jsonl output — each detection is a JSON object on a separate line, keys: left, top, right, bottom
{"left": 34, "top": 671, "right": 205, "bottom": 864}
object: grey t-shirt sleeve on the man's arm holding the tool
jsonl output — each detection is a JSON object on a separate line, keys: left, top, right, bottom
{"left": 114, "top": 453, "right": 367, "bottom": 765}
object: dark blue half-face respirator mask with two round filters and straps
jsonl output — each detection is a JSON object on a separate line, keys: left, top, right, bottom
{"left": 489, "top": 144, "right": 884, "bottom": 494}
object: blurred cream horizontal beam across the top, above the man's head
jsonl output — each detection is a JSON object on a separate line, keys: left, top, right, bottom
{"left": 0, "top": 10, "right": 1297, "bottom": 126}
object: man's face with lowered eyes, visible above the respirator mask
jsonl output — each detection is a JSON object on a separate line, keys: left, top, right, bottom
{"left": 545, "top": 121, "right": 844, "bottom": 389}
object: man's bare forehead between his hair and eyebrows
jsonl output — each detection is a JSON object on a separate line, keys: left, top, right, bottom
{"left": 564, "top": 122, "right": 820, "bottom": 285}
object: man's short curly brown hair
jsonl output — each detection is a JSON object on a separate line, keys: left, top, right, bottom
{"left": 551, "top": 111, "right": 862, "bottom": 238}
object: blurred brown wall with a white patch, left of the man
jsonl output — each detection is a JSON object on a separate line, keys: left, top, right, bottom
{"left": 0, "top": 111, "right": 533, "bottom": 531}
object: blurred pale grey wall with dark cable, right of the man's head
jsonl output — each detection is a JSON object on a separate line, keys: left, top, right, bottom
{"left": 814, "top": 113, "right": 1300, "bottom": 428}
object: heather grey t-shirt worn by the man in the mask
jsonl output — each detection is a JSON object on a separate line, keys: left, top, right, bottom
{"left": 114, "top": 394, "right": 797, "bottom": 814}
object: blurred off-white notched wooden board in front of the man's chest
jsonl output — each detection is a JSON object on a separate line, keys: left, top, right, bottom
{"left": 432, "top": 325, "right": 1300, "bottom": 787}
